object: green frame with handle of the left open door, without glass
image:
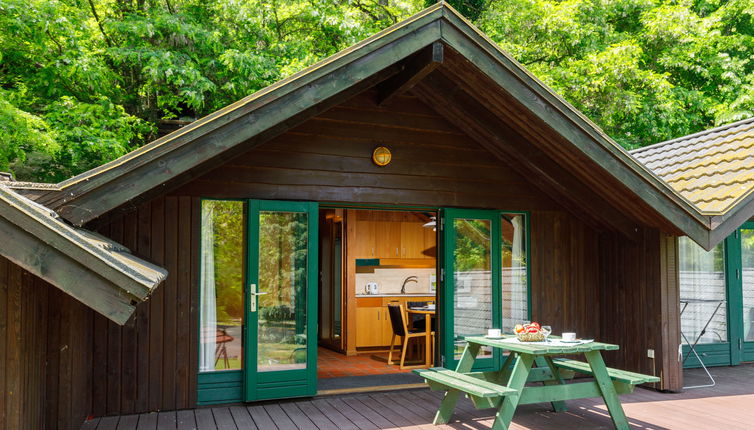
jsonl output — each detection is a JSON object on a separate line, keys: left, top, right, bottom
{"left": 243, "top": 200, "right": 319, "bottom": 401}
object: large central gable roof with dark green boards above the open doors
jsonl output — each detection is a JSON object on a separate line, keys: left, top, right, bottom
{"left": 19, "top": 2, "right": 728, "bottom": 248}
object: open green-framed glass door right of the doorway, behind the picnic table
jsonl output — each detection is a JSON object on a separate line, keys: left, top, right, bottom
{"left": 443, "top": 209, "right": 501, "bottom": 369}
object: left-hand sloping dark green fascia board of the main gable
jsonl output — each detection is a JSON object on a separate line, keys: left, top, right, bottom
{"left": 56, "top": 20, "right": 440, "bottom": 226}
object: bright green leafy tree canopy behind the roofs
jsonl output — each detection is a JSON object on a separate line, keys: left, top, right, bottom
{"left": 0, "top": 0, "right": 754, "bottom": 181}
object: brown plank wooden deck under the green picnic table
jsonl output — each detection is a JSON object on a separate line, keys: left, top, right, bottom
{"left": 82, "top": 365, "right": 754, "bottom": 430}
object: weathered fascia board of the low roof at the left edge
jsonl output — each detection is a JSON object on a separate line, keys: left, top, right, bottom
{"left": 0, "top": 217, "right": 136, "bottom": 325}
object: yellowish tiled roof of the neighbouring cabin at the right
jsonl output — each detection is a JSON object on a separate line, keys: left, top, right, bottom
{"left": 631, "top": 117, "right": 754, "bottom": 247}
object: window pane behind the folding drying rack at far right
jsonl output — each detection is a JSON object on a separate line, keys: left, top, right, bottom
{"left": 678, "top": 237, "right": 728, "bottom": 343}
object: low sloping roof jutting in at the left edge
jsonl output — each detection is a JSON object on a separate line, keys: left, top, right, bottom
{"left": 0, "top": 185, "right": 167, "bottom": 324}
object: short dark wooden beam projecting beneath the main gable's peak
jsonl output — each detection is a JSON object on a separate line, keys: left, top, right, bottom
{"left": 377, "top": 42, "right": 445, "bottom": 106}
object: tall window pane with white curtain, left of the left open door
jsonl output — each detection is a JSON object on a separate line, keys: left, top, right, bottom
{"left": 199, "top": 200, "right": 244, "bottom": 372}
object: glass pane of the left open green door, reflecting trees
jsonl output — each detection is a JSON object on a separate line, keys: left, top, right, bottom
{"left": 257, "top": 211, "right": 308, "bottom": 372}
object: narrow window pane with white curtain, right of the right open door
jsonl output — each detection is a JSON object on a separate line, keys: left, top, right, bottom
{"left": 501, "top": 214, "right": 529, "bottom": 331}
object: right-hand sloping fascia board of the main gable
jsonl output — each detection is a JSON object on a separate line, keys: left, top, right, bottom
{"left": 434, "top": 10, "right": 710, "bottom": 243}
